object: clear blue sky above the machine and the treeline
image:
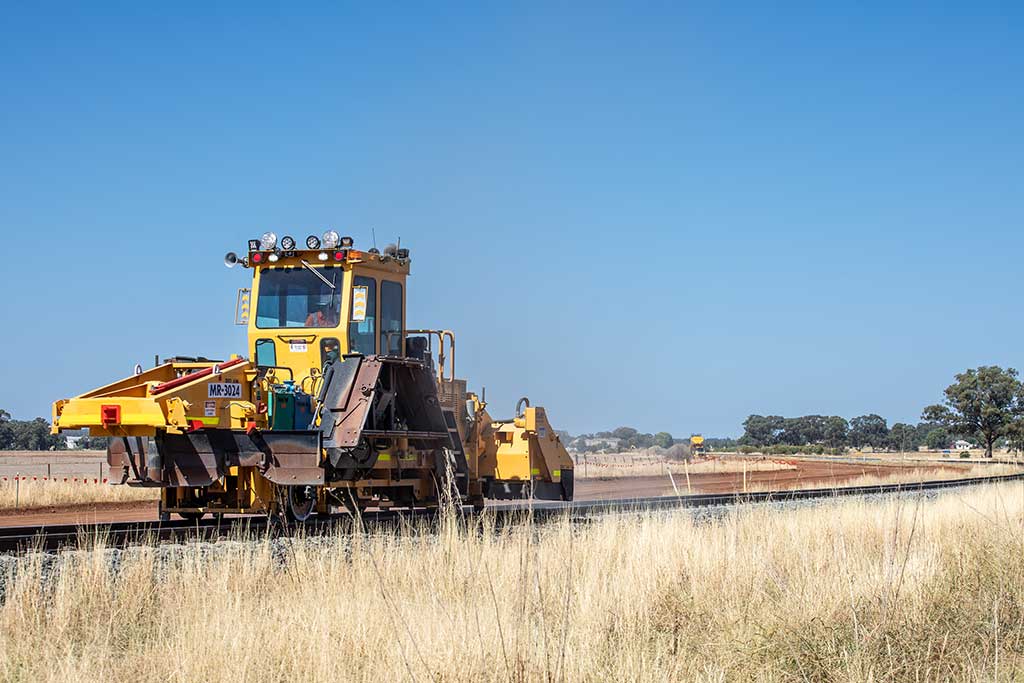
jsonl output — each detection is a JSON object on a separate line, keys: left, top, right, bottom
{"left": 0, "top": 2, "right": 1024, "bottom": 435}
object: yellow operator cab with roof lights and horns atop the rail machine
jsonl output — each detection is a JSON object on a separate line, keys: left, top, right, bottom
{"left": 224, "top": 230, "right": 410, "bottom": 391}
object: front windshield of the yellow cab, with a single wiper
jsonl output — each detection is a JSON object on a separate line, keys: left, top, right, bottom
{"left": 256, "top": 265, "right": 344, "bottom": 329}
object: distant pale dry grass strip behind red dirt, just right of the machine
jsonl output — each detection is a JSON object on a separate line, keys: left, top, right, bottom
{"left": 573, "top": 454, "right": 797, "bottom": 479}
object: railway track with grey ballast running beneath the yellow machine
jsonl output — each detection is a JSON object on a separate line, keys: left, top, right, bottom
{"left": 0, "top": 473, "right": 1024, "bottom": 553}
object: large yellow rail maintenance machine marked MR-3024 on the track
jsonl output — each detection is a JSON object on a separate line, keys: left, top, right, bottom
{"left": 53, "top": 230, "right": 573, "bottom": 520}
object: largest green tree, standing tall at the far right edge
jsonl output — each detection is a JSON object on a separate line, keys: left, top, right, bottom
{"left": 922, "top": 366, "right": 1024, "bottom": 458}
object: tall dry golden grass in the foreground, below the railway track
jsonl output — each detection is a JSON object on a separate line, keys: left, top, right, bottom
{"left": 0, "top": 483, "right": 1024, "bottom": 683}
